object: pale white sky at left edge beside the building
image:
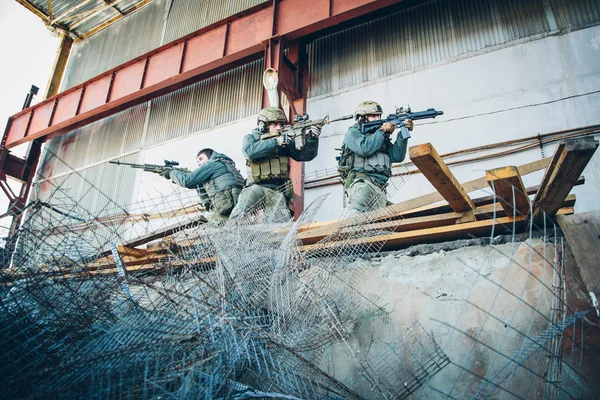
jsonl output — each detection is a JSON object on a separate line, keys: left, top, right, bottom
{"left": 0, "top": 0, "right": 60, "bottom": 231}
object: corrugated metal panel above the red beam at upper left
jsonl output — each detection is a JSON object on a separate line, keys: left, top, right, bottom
{"left": 62, "top": 0, "right": 265, "bottom": 90}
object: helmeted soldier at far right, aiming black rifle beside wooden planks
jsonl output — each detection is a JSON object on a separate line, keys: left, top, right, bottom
{"left": 339, "top": 101, "right": 414, "bottom": 215}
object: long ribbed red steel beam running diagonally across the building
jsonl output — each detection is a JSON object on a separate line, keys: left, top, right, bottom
{"left": 2, "top": 0, "right": 402, "bottom": 148}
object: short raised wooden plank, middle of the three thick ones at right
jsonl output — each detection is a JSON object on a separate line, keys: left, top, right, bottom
{"left": 485, "top": 165, "right": 529, "bottom": 215}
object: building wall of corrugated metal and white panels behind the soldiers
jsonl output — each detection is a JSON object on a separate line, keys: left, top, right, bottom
{"left": 34, "top": 0, "right": 600, "bottom": 220}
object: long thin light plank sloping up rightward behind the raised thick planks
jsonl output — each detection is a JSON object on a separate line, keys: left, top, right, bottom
{"left": 299, "top": 157, "right": 551, "bottom": 240}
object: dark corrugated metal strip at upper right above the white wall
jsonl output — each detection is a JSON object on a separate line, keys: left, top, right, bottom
{"left": 309, "top": 0, "right": 600, "bottom": 97}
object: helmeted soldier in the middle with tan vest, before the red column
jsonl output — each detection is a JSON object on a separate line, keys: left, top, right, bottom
{"left": 231, "top": 107, "right": 321, "bottom": 219}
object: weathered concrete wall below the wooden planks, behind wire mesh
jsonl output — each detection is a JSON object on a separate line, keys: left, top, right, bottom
{"left": 321, "top": 239, "right": 579, "bottom": 398}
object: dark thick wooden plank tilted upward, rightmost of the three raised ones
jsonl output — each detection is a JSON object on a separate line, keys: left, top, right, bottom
{"left": 533, "top": 136, "right": 598, "bottom": 221}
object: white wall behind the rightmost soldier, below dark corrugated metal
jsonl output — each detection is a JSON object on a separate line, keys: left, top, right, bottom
{"left": 306, "top": 26, "right": 600, "bottom": 220}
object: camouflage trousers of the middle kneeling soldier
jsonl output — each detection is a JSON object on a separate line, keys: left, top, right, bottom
{"left": 229, "top": 184, "right": 290, "bottom": 219}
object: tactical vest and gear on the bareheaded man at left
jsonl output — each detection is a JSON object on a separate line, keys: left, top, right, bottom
{"left": 202, "top": 157, "right": 244, "bottom": 215}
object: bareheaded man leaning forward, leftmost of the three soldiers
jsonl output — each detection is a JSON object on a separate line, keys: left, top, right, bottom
{"left": 161, "top": 149, "right": 244, "bottom": 222}
